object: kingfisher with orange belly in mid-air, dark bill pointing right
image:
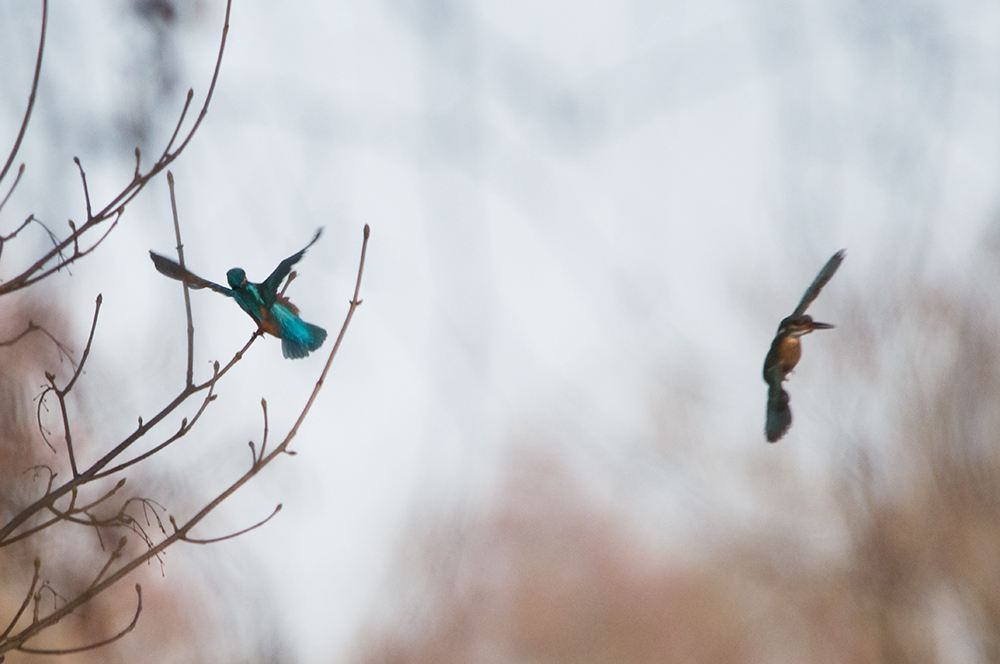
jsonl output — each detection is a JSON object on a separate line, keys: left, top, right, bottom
{"left": 764, "top": 249, "right": 846, "bottom": 443}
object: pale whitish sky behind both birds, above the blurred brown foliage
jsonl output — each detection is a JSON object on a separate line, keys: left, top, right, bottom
{"left": 0, "top": 0, "right": 1000, "bottom": 663}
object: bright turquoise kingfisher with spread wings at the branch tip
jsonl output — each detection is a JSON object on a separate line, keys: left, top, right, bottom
{"left": 149, "top": 228, "right": 326, "bottom": 359}
